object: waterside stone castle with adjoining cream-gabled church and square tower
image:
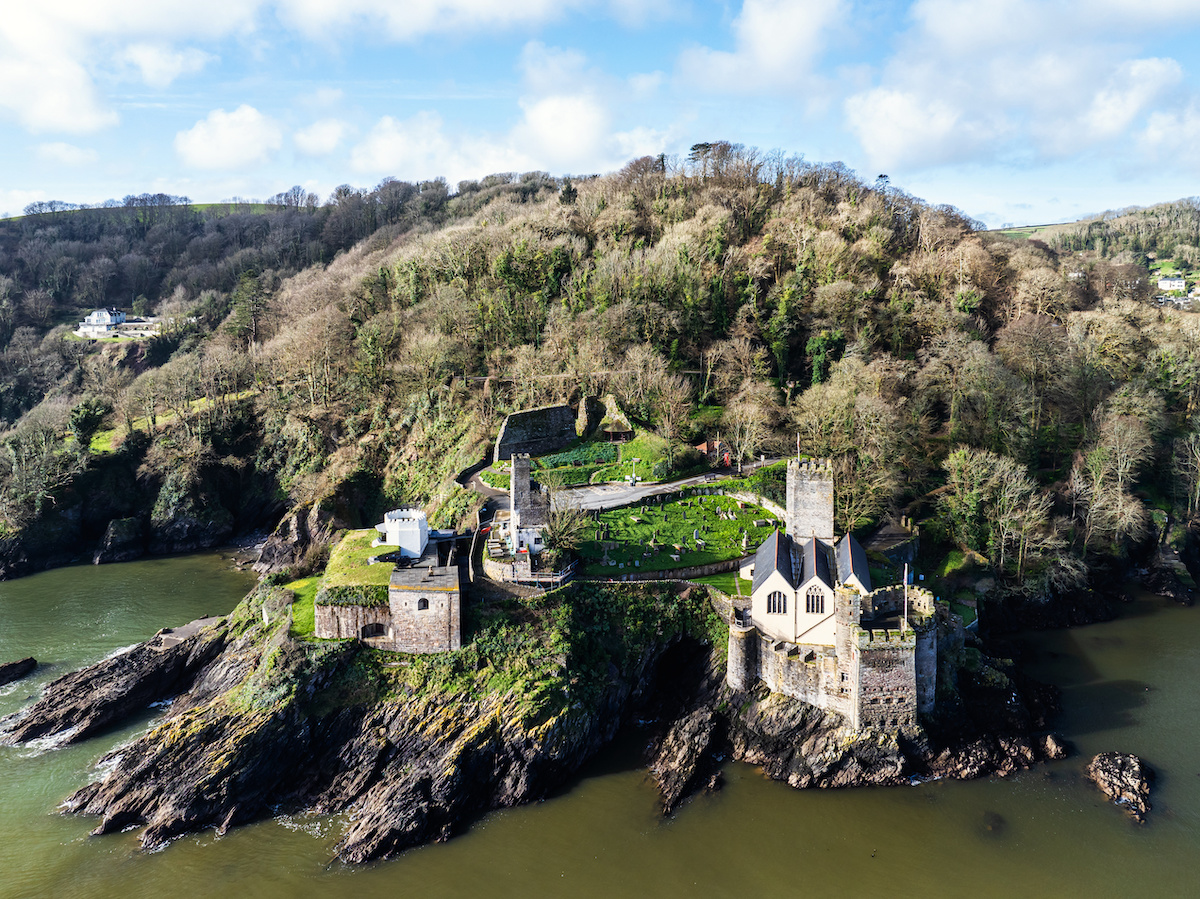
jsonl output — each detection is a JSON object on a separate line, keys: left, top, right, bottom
{"left": 726, "top": 460, "right": 937, "bottom": 731}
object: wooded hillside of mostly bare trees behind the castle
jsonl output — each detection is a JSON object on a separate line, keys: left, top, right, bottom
{"left": 0, "top": 143, "right": 1200, "bottom": 595}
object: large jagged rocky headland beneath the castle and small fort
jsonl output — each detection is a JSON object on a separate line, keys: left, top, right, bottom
{"left": 0, "top": 586, "right": 1070, "bottom": 862}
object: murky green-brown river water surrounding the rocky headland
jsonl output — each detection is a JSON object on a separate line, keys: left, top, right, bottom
{"left": 0, "top": 555, "right": 1200, "bottom": 899}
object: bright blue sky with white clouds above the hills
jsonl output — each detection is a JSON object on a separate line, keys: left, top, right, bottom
{"left": 0, "top": 0, "right": 1200, "bottom": 226}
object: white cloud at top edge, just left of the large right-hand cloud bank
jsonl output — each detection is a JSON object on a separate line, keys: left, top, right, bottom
{"left": 679, "top": 0, "right": 848, "bottom": 94}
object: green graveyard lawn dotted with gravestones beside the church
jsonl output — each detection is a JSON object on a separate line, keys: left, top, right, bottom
{"left": 578, "top": 496, "right": 776, "bottom": 576}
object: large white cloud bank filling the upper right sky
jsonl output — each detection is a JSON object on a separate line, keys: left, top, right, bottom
{"left": 842, "top": 0, "right": 1200, "bottom": 170}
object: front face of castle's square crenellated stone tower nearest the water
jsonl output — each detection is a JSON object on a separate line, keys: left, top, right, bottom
{"left": 856, "top": 630, "right": 917, "bottom": 731}
